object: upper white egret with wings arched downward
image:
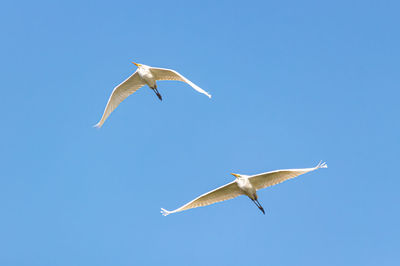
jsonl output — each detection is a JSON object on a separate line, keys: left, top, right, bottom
{"left": 95, "top": 62, "right": 211, "bottom": 128}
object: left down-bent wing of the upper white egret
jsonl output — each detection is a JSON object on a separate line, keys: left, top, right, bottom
{"left": 95, "top": 71, "right": 145, "bottom": 128}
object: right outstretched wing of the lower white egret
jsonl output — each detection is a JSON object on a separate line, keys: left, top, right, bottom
{"left": 249, "top": 162, "right": 328, "bottom": 190}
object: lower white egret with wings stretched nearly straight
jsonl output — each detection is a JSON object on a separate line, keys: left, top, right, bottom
{"left": 161, "top": 162, "right": 328, "bottom": 216}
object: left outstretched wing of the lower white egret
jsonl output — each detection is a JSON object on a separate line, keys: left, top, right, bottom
{"left": 161, "top": 181, "right": 243, "bottom": 216}
